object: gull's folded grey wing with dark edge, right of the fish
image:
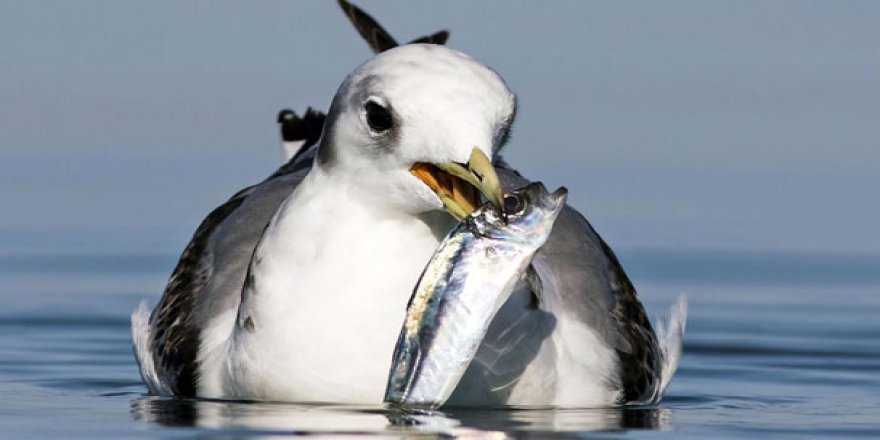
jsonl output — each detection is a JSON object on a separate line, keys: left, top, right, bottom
{"left": 496, "top": 158, "right": 661, "bottom": 403}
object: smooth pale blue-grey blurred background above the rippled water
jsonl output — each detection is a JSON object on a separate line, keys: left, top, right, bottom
{"left": 0, "top": 0, "right": 880, "bottom": 263}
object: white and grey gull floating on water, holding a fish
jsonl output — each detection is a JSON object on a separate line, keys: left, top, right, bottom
{"left": 132, "top": 1, "right": 686, "bottom": 407}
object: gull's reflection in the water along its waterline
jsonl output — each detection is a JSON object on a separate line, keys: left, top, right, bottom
{"left": 132, "top": 397, "right": 672, "bottom": 436}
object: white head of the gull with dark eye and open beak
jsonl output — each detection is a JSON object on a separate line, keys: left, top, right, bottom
{"left": 317, "top": 44, "right": 516, "bottom": 218}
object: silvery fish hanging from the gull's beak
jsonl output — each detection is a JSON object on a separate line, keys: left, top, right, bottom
{"left": 385, "top": 182, "right": 568, "bottom": 409}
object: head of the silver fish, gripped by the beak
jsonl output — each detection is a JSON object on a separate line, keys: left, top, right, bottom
{"left": 470, "top": 182, "right": 568, "bottom": 248}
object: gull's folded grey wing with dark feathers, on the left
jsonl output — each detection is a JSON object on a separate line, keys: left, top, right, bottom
{"left": 150, "top": 109, "right": 324, "bottom": 397}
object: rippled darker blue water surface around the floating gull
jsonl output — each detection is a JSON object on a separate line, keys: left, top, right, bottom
{"left": 0, "top": 251, "right": 880, "bottom": 438}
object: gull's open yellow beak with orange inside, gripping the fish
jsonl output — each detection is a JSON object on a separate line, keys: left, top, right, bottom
{"left": 409, "top": 147, "right": 502, "bottom": 220}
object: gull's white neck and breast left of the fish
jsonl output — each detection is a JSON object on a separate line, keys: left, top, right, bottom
{"left": 223, "top": 168, "right": 451, "bottom": 402}
